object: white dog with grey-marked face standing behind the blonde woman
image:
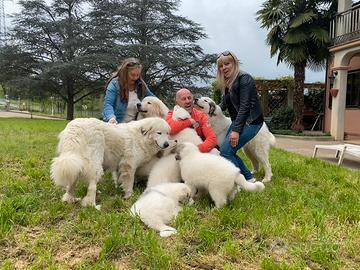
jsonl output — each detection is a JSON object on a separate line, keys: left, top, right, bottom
{"left": 195, "top": 97, "right": 275, "bottom": 183}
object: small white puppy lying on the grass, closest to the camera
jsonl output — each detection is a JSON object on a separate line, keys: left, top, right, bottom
{"left": 130, "top": 183, "right": 191, "bottom": 237}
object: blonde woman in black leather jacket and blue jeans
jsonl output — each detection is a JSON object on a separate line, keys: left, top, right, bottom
{"left": 216, "top": 51, "right": 264, "bottom": 182}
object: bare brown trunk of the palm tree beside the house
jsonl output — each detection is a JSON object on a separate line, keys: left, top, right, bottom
{"left": 291, "top": 62, "right": 306, "bottom": 132}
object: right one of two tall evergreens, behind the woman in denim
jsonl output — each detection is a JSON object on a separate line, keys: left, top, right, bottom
{"left": 92, "top": 0, "right": 215, "bottom": 101}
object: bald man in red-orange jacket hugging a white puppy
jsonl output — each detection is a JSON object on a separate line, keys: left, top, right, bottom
{"left": 166, "top": 88, "right": 217, "bottom": 153}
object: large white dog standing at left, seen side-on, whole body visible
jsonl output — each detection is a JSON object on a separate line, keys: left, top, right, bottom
{"left": 51, "top": 117, "right": 170, "bottom": 207}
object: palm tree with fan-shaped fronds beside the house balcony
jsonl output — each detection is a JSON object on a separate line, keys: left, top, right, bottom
{"left": 256, "top": 0, "right": 337, "bottom": 132}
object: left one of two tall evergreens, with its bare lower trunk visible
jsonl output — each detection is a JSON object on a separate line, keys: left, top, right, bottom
{"left": 5, "top": 0, "right": 109, "bottom": 119}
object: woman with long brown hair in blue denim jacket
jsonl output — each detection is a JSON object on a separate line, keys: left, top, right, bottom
{"left": 102, "top": 58, "right": 154, "bottom": 124}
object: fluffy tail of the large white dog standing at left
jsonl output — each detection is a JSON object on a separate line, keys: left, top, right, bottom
{"left": 50, "top": 152, "right": 84, "bottom": 187}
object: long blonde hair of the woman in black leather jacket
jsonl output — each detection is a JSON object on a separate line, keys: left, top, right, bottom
{"left": 216, "top": 51, "right": 240, "bottom": 93}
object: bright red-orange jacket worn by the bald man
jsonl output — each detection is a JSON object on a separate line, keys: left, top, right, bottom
{"left": 166, "top": 109, "right": 217, "bottom": 153}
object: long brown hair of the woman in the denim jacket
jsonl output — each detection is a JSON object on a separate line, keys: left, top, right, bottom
{"left": 105, "top": 57, "right": 146, "bottom": 102}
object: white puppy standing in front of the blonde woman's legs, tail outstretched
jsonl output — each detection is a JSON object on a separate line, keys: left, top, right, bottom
{"left": 176, "top": 143, "right": 264, "bottom": 208}
